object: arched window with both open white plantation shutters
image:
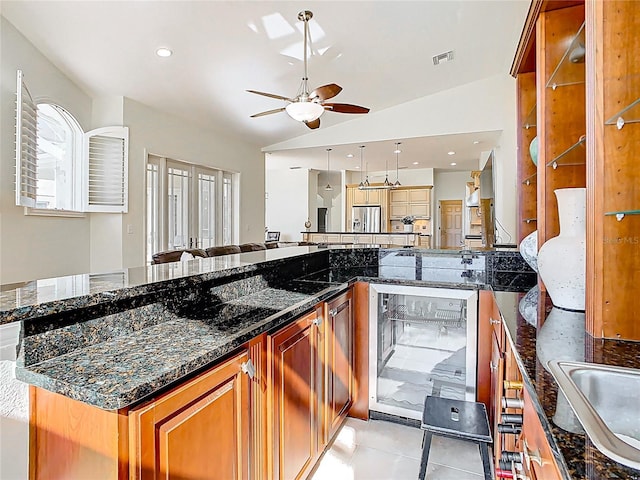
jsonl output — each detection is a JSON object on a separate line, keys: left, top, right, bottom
{"left": 16, "top": 70, "right": 129, "bottom": 214}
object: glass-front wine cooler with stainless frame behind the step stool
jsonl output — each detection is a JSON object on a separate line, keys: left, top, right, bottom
{"left": 369, "top": 284, "right": 478, "bottom": 420}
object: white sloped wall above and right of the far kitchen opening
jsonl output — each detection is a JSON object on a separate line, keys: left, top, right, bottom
{"left": 263, "top": 71, "right": 517, "bottom": 240}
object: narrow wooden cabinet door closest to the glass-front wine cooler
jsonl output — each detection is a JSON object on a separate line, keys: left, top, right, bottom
{"left": 324, "top": 292, "right": 353, "bottom": 442}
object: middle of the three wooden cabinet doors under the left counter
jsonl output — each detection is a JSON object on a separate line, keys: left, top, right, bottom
{"left": 267, "top": 306, "right": 324, "bottom": 480}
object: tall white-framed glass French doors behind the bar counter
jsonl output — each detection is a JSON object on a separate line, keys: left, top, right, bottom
{"left": 146, "top": 155, "right": 234, "bottom": 262}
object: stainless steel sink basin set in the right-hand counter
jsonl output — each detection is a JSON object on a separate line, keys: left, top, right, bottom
{"left": 549, "top": 360, "right": 640, "bottom": 469}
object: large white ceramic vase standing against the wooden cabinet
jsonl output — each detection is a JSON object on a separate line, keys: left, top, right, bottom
{"left": 538, "top": 188, "right": 586, "bottom": 311}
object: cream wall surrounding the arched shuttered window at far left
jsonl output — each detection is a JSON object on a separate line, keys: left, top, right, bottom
{"left": 0, "top": 17, "right": 91, "bottom": 283}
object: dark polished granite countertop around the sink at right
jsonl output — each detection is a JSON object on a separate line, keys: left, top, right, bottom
{"left": 495, "top": 288, "right": 640, "bottom": 480}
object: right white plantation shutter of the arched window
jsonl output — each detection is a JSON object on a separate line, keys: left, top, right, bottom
{"left": 84, "top": 127, "right": 129, "bottom": 213}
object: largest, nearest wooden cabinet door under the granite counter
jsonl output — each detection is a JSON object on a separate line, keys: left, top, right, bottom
{"left": 129, "top": 351, "right": 251, "bottom": 480}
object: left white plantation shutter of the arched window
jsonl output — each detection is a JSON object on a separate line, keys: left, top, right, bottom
{"left": 16, "top": 70, "right": 38, "bottom": 207}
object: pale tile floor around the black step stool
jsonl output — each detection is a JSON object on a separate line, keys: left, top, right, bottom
{"left": 309, "top": 418, "right": 484, "bottom": 480}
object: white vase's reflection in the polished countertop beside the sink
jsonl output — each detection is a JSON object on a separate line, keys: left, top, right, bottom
{"left": 536, "top": 308, "right": 585, "bottom": 433}
